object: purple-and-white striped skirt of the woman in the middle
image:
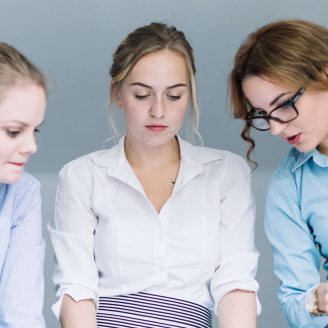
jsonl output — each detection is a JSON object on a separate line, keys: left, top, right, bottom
{"left": 97, "top": 293, "right": 212, "bottom": 328}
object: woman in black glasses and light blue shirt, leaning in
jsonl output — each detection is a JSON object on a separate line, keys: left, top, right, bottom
{"left": 230, "top": 20, "right": 328, "bottom": 328}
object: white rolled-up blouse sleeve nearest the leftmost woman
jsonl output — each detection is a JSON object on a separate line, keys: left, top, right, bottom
{"left": 48, "top": 160, "right": 98, "bottom": 317}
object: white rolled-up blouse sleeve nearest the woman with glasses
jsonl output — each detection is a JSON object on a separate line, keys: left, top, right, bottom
{"left": 211, "top": 154, "right": 260, "bottom": 313}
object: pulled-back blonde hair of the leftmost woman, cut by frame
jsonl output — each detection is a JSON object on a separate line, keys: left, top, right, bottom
{"left": 0, "top": 42, "right": 46, "bottom": 101}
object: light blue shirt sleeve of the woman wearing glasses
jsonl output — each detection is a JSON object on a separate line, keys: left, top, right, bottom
{"left": 265, "top": 162, "right": 328, "bottom": 328}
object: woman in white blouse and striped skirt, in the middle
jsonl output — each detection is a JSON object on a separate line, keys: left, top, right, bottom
{"left": 49, "top": 23, "right": 258, "bottom": 328}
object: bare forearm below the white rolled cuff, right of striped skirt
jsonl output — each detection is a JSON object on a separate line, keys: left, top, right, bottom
{"left": 217, "top": 290, "right": 256, "bottom": 328}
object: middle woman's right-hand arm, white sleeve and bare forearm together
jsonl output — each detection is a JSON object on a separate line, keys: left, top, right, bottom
{"left": 211, "top": 155, "right": 260, "bottom": 328}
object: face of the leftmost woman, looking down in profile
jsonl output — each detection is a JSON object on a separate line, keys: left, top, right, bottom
{"left": 0, "top": 84, "right": 46, "bottom": 183}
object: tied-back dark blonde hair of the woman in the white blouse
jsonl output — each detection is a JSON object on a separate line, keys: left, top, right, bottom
{"left": 109, "top": 22, "right": 200, "bottom": 137}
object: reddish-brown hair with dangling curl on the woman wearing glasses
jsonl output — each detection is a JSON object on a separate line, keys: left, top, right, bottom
{"left": 229, "top": 19, "right": 328, "bottom": 163}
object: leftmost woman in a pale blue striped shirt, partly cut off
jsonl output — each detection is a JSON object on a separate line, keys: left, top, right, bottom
{"left": 0, "top": 43, "right": 46, "bottom": 328}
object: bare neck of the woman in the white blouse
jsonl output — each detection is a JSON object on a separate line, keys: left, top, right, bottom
{"left": 124, "top": 137, "right": 180, "bottom": 167}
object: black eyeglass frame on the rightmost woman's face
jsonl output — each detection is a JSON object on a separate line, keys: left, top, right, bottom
{"left": 245, "top": 87, "right": 305, "bottom": 131}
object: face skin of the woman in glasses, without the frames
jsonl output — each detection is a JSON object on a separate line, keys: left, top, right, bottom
{"left": 242, "top": 76, "right": 328, "bottom": 152}
